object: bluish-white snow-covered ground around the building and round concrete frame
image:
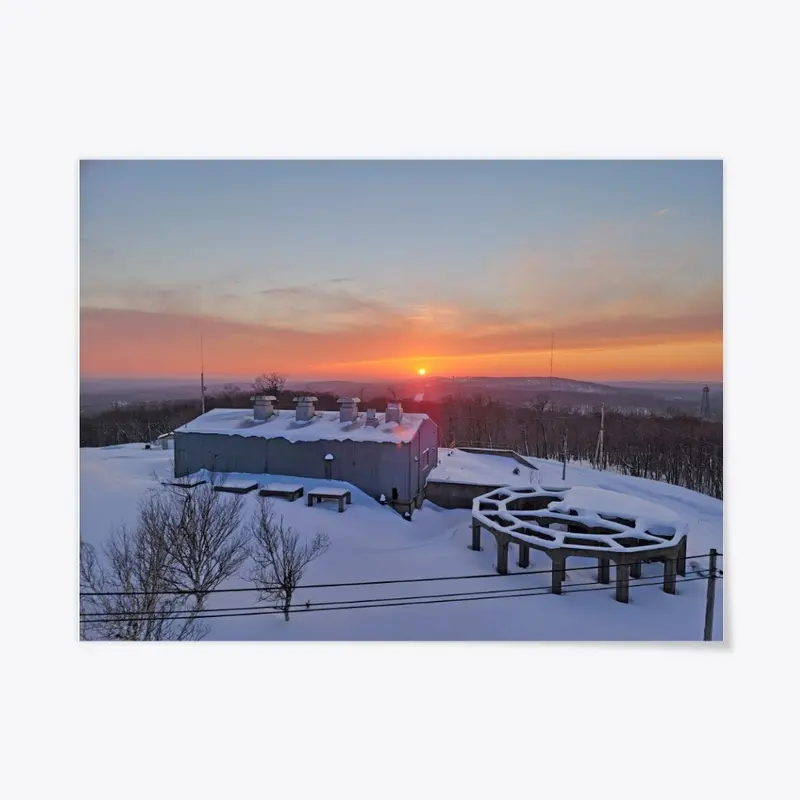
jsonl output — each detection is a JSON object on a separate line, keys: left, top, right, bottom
{"left": 80, "top": 444, "right": 724, "bottom": 641}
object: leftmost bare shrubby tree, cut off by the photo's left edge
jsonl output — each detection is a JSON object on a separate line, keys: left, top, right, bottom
{"left": 80, "top": 496, "right": 207, "bottom": 641}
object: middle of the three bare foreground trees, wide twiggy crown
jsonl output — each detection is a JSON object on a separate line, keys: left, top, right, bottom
{"left": 153, "top": 475, "right": 247, "bottom": 611}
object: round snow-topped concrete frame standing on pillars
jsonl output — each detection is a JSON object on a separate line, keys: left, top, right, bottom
{"left": 471, "top": 486, "right": 688, "bottom": 603}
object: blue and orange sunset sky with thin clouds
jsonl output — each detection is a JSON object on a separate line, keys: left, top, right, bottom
{"left": 80, "top": 161, "right": 723, "bottom": 381}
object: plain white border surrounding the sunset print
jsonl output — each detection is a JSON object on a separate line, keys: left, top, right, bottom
{"left": 0, "top": 0, "right": 797, "bottom": 800}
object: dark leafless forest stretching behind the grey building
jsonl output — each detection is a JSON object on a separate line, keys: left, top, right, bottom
{"left": 80, "top": 376, "right": 723, "bottom": 499}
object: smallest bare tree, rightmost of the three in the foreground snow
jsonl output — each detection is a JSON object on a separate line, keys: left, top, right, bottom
{"left": 250, "top": 498, "right": 330, "bottom": 622}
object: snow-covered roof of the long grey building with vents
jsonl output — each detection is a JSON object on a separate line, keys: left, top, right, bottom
{"left": 175, "top": 408, "right": 428, "bottom": 444}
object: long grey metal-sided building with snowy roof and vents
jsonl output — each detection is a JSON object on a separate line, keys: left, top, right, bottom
{"left": 174, "top": 395, "right": 438, "bottom": 509}
